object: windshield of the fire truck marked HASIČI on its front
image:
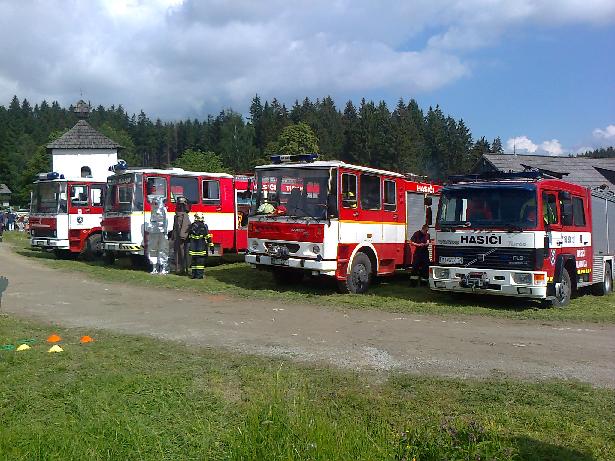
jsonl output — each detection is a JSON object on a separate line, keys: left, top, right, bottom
{"left": 438, "top": 186, "right": 537, "bottom": 230}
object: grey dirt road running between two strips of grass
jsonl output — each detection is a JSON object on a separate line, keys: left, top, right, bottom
{"left": 0, "top": 244, "right": 615, "bottom": 388}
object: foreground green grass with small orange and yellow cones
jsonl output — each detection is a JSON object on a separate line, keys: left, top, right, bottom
{"left": 0, "top": 315, "right": 615, "bottom": 461}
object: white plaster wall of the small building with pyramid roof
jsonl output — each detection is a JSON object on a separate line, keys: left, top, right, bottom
{"left": 51, "top": 149, "right": 117, "bottom": 181}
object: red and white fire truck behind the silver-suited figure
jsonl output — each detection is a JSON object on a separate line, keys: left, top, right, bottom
{"left": 102, "top": 168, "right": 252, "bottom": 264}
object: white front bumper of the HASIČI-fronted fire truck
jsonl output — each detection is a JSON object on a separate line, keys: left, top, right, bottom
{"left": 429, "top": 266, "right": 547, "bottom": 299}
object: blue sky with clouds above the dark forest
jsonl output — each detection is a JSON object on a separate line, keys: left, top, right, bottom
{"left": 0, "top": 0, "right": 615, "bottom": 155}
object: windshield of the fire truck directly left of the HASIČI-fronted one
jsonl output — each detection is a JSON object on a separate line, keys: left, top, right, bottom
{"left": 251, "top": 167, "right": 337, "bottom": 219}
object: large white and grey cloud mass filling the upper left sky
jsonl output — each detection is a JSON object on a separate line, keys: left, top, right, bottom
{"left": 0, "top": 0, "right": 615, "bottom": 117}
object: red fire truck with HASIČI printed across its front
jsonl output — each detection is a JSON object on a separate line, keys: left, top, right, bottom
{"left": 429, "top": 171, "right": 615, "bottom": 306}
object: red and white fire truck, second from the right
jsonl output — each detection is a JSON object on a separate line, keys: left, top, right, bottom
{"left": 246, "top": 155, "right": 440, "bottom": 293}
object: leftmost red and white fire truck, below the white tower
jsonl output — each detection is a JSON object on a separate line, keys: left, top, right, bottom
{"left": 30, "top": 172, "right": 106, "bottom": 259}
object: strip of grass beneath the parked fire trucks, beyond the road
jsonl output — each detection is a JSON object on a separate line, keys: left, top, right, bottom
{"left": 5, "top": 233, "right": 615, "bottom": 322}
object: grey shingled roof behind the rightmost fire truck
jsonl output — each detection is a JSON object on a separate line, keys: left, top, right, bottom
{"left": 473, "top": 154, "right": 615, "bottom": 187}
